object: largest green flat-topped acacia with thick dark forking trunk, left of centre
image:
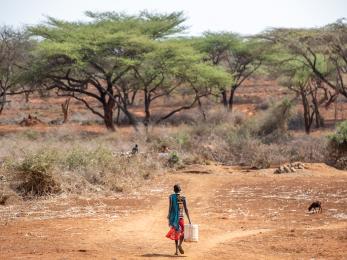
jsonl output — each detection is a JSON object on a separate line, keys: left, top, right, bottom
{"left": 29, "top": 12, "right": 184, "bottom": 130}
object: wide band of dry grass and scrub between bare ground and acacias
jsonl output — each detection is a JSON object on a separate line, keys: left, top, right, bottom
{"left": 0, "top": 103, "right": 334, "bottom": 201}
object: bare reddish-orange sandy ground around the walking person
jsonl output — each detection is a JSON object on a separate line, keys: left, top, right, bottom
{"left": 0, "top": 164, "right": 347, "bottom": 259}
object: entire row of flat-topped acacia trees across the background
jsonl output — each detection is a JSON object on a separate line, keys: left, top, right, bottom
{"left": 0, "top": 11, "right": 347, "bottom": 132}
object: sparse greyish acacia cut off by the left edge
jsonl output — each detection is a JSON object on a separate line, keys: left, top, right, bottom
{"left": 0, "top": 26, "right": 32, "bottom": 113}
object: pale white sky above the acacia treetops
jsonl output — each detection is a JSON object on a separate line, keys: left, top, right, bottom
{"left": 0, "top": 0, "right": 347, "bottom": 35}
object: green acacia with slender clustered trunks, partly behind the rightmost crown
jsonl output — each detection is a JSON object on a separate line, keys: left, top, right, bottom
{"left": 267, "top": 37, "right": 334, "bottom": 134}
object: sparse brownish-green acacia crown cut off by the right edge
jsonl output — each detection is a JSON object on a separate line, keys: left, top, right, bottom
{"left": 259, "top": 20, "right": 347, "bottom": 99}
